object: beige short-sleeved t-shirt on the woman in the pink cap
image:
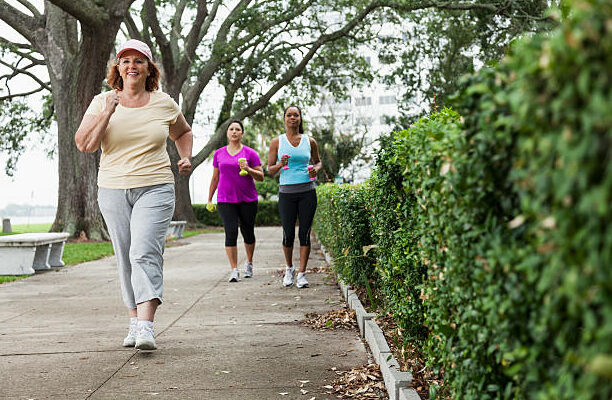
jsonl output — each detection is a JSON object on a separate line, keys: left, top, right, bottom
{"left": 85, "top": 91, "right": 181, "bottom": 189}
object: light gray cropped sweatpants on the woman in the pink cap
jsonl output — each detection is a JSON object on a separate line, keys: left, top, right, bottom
{"left": 98, "top": 183, "right": 174, "bottom": 308}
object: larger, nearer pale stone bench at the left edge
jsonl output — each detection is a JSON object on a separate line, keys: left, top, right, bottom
{"left": 0, "top": 232, "right": 68, "bottom": 275}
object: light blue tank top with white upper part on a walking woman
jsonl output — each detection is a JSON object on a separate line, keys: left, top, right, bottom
{"left": 277, "top": 134, "right": 310, "bottom": 185}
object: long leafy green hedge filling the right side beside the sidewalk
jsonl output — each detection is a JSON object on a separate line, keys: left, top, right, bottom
{"left": 315, "top": 0, "right": 612, "bottom": 399}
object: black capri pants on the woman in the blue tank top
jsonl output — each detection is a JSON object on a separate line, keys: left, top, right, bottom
{"left": 278, "top": 190, "right": 317, "bottom": 247}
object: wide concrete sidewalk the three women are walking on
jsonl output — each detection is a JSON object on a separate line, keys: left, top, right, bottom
{"left": 0, "top": 227, "right": 368, "bottom": 400}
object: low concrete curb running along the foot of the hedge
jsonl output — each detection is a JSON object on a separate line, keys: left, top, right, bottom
{"left": 321, "top": 241, "right": 421, "bottom": 400}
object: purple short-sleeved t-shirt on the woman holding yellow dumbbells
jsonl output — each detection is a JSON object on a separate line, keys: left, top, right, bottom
{"left": 213, "top": 145, "right": 261, "bottom": 203}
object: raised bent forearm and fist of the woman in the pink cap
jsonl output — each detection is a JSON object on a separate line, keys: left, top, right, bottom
{"left": 74, "top": 91, "right": 119, "bottom": 153}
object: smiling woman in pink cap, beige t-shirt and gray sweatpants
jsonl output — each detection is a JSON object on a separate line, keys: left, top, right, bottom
{"left": 75, "top": 39, "right": 193, "bottom": 350}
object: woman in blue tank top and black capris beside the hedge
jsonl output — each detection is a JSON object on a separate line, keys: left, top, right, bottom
{"left": 268, "top": 106, "right": 322, "bottom": 288}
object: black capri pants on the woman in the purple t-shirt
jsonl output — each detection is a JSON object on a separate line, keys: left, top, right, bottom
{"left": 217, "top": 201, "right": 257, "bottom": 247}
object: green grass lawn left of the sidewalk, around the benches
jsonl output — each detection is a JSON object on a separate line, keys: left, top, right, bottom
{"left": 0, "top": 224, "right": 218, "bottom": 283}
